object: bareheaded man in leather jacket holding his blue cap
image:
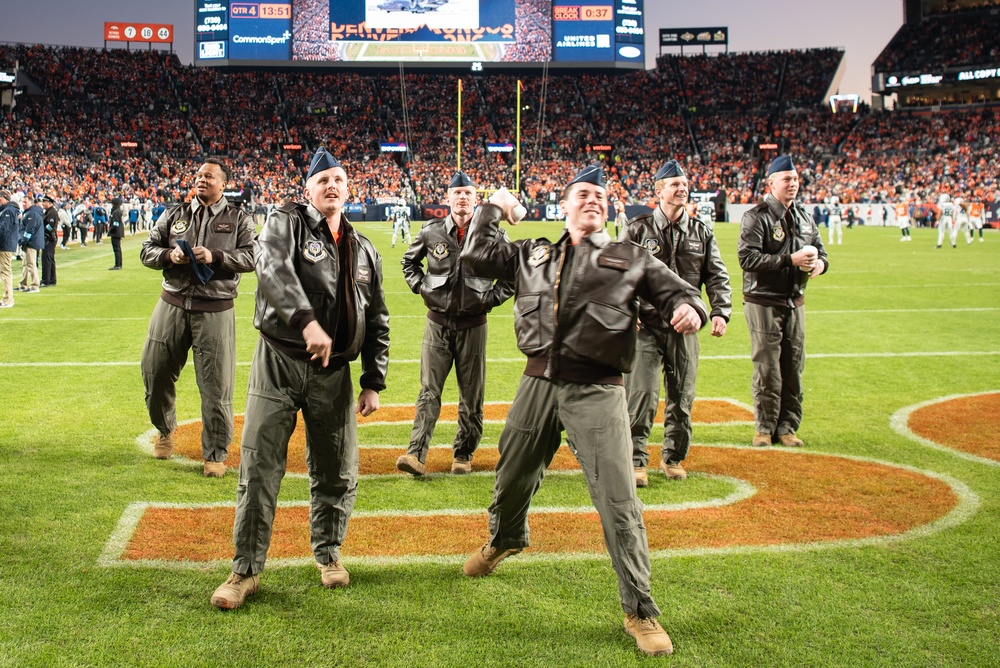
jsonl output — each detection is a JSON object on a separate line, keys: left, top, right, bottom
{"left": 140, "top": 160, "right": 254, "bottom": 478}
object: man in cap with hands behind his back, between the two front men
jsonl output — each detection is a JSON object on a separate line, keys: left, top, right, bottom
{"left": 396, "top": 172, "right": 514, "bottom": 475}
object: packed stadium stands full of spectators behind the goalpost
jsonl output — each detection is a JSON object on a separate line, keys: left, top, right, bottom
{"left": 0, "top": 39, "right": 1000, "bottom": 218}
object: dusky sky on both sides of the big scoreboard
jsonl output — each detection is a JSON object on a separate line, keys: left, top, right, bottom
{"left": 0, "top": 0, "right": 903, "bottom": 99}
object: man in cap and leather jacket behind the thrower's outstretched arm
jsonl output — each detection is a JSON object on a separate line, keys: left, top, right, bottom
{"left": 622, "top": 160, "right": 733, "bottom": 487}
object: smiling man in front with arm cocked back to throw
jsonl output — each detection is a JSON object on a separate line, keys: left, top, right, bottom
{"left": 462, "top": 165, "right": 708, "bottom": 654}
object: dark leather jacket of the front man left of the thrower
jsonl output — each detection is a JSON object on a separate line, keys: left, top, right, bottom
{"left": 254, "top": 202, "right": 389, "bottom": 392}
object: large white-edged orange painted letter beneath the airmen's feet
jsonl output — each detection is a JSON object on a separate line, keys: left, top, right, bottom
{"left": 109, "top": 400, "right": 975, "bottom": 565}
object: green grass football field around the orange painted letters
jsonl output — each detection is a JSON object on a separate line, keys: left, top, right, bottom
{"left": 0, "top": 223, "right": 1000, "bottom": 668}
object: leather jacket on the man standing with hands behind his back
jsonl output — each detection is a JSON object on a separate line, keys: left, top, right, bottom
{"left": 402, "top": 216, "right": 514, "bottom": 329}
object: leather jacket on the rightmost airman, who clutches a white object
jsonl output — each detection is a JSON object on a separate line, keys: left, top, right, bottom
{"left": 737, "top": 195, "right": 830, "bottom": 307}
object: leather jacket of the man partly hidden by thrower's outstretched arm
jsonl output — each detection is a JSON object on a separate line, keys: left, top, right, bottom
{"left": 622, "top": 206, "right": 733, "bottom": 330}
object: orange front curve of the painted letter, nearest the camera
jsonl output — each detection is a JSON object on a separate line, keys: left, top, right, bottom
{"left": 121, "top": 446, "right": 958, "bottom": 562}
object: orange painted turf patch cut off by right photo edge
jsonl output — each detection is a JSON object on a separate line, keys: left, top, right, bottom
{"left": 907, "top": 392, "right": 1000, "bottom": 461}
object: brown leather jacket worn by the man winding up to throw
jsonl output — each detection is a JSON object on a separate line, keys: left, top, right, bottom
{"left": 462, "top": 204, "right": 708, "bottom": 383}
